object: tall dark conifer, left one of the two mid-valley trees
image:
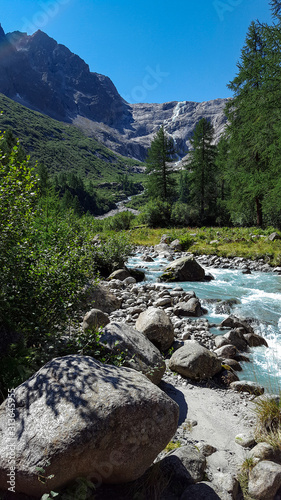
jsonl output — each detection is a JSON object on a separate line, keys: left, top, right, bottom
{"left": 146, "top": 126, "right": 175, "bottom": 201}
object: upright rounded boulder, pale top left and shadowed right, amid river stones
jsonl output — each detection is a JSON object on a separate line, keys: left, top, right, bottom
{"left": 136, "top": 307, "right": 174, "bottom": 351}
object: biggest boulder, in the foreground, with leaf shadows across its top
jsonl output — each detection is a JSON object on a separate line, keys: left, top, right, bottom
{"left": 0, "top": 355, "right": 179, "bottom": 497}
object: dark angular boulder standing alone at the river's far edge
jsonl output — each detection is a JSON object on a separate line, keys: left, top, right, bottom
{"left": 160, "top": 255, "right": 205, "bottom": 281}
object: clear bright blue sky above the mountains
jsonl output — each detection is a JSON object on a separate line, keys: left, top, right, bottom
{"left": 0, "top": 0, "right": 272, "bottom": 102}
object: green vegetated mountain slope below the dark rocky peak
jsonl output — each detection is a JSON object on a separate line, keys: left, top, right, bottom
{"left": 0, "top": 94, "right": 142, "bottom": 202}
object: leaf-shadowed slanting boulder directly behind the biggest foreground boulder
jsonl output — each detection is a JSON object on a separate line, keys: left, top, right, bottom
{"left": 100, "top": 322, "right": 166, "bottom": 385}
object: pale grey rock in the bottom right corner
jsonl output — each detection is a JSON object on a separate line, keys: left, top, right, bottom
{"left": 248, "top": 461, "right": 281, "bottom": 500}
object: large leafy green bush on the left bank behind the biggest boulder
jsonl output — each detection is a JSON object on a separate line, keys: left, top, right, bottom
{"left": 0, "top": 136, "right": 135, "bottom": 398}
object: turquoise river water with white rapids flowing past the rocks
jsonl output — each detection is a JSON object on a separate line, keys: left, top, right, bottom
{"left": 128, "top": 254, "right": 281, "bottom": 393}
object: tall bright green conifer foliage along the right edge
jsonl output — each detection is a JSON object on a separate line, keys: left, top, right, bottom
{"left": 225, "top": 15, "right": 281, "bottom": 226}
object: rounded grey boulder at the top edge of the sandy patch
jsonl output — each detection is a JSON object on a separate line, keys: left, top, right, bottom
{"left": 169, "top": 340, "right": 221, "bottom": 380}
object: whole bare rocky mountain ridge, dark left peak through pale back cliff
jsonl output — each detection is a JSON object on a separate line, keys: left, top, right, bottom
{"left": 0, "top": 25, "right": 227, "bottom": 160}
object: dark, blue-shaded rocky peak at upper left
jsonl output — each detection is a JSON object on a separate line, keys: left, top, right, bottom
{"left": 0, "top": 30, "right": 127, "bottom": 125}
